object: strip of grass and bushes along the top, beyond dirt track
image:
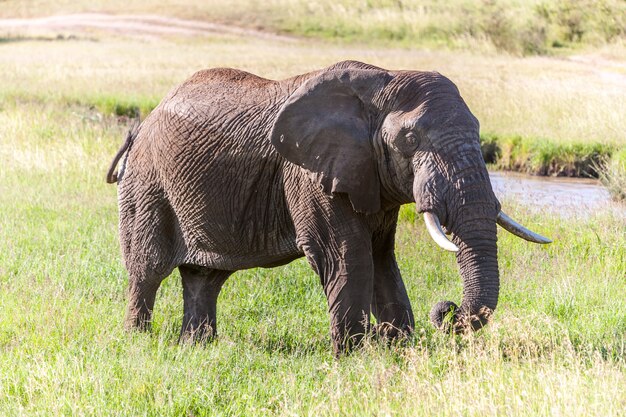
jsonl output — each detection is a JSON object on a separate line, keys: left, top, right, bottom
{"left": 0, "top": 0, "right": 626, "bottom": 55}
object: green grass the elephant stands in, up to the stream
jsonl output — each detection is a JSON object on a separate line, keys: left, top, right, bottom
{"left": 0, "top": 103, "right": 626, "bottom": 416}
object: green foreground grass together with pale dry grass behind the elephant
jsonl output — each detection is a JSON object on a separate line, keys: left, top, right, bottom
{"left": 0, "top": 11, "right": 626, "bottom": 416}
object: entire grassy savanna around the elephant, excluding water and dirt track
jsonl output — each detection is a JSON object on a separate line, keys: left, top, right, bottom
{"left": 0, "top": 0, "right": 626, "bottom": 417}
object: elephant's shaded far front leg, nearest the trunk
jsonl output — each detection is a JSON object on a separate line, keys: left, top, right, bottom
{"left": 372, "top": 247, "right": 415, "bottom": 339}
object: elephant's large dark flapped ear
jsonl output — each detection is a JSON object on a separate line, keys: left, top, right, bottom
{"left": 270, "top": 69, "right": 390, "bottom": 214}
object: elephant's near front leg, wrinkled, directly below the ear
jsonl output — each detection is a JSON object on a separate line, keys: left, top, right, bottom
{"left": 304, "top": 234, "right": 374, "bottom": 356}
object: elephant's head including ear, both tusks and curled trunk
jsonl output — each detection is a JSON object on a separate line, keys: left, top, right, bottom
{"left": 270, "top": 61, "right": 549, "bottom": 331}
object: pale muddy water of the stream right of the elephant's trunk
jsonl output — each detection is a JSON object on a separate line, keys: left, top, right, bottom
{"left": 489, "top": 172, "right": 626, "bottom": 216}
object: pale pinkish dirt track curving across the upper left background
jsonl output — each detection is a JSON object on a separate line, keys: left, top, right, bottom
{"left": 0, "top": 13, "right": 296, "bottom": 42}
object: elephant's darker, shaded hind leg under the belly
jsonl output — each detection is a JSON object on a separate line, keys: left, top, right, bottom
{"left": 178, "top": 265, "right": 232, "bottom": 342}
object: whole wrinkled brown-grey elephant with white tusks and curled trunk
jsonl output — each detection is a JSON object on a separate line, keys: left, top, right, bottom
{"left": 107, "top": 61, "right": 550, "bottom": 355}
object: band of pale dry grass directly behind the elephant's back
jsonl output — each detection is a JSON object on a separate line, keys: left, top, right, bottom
{"left": 0, "top": 36, "right": 626, "bottom": 146}
